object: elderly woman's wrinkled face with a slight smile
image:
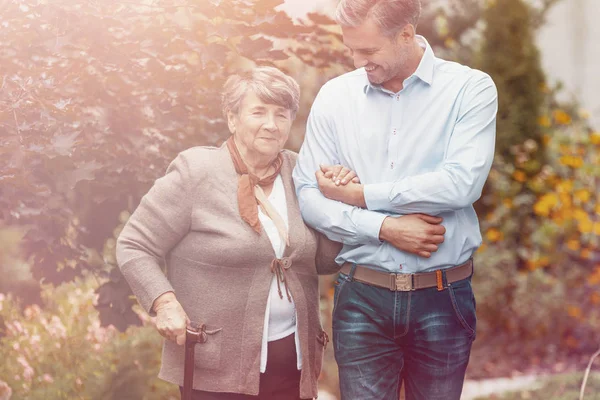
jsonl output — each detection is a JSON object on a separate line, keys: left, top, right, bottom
{"left": 227, "top": 90, "right": 292, "bottom": 159}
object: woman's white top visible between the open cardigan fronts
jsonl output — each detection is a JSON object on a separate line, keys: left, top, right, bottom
{"left": 258, "top": 175, "right": 302, "bottom": 372}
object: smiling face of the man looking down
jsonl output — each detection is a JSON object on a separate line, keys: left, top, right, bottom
{"left": 342, "top": 18, "right": 409, "bottom": 86}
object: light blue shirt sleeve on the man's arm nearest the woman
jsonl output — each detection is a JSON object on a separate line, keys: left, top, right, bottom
{"left": 293, "top": 89, "right": 386, "bottom": 245}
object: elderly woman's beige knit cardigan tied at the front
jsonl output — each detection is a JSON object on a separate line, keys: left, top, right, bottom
{"left": 117, "top": 142, "right": 341, "bottom": 399}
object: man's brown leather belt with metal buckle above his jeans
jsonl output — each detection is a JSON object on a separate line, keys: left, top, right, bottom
{"left": 340, "top": 259, "right": 473, "bottom": 292}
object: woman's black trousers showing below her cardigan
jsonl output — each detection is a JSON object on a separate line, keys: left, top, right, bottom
{"left": 179, "top": 334, "right": 300, "bottom": 400}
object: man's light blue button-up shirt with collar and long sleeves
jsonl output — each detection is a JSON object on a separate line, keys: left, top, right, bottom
{"left": 294, "top": 36, "right": 498, "bottom": 273}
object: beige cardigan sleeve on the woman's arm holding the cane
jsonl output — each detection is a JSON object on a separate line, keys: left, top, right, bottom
{"left": 117, "top": 153, "right": 193, "bottom": 315}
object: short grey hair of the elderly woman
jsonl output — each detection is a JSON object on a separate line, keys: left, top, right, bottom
{"left": 221, "top": 66, "right": 300, "bottom": 120}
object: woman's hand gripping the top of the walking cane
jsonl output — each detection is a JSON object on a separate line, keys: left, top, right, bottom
{"left": 153, "top": 292, "right": 190, "bottom": 346}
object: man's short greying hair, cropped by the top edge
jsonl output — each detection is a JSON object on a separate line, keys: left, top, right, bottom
{"left": 335, "top": 0, "right": 421, "bottom": 38}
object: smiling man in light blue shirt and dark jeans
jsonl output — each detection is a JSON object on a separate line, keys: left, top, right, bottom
{"left": 294, "top": 0, "right": 497, "bottom": 400}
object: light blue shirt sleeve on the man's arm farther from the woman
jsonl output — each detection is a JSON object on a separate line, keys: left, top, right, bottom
{"left": 364, "top": 73, "right": 498, "bottom": 215}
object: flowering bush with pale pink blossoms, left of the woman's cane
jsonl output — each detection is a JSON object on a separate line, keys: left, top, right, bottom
{"left": 0, "top": 279, "right": 179, "bottom": 400}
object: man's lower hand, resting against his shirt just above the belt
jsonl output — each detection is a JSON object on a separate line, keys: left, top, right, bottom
{"left": 379, "top": 214, "right": 446, "bottom": 258}
